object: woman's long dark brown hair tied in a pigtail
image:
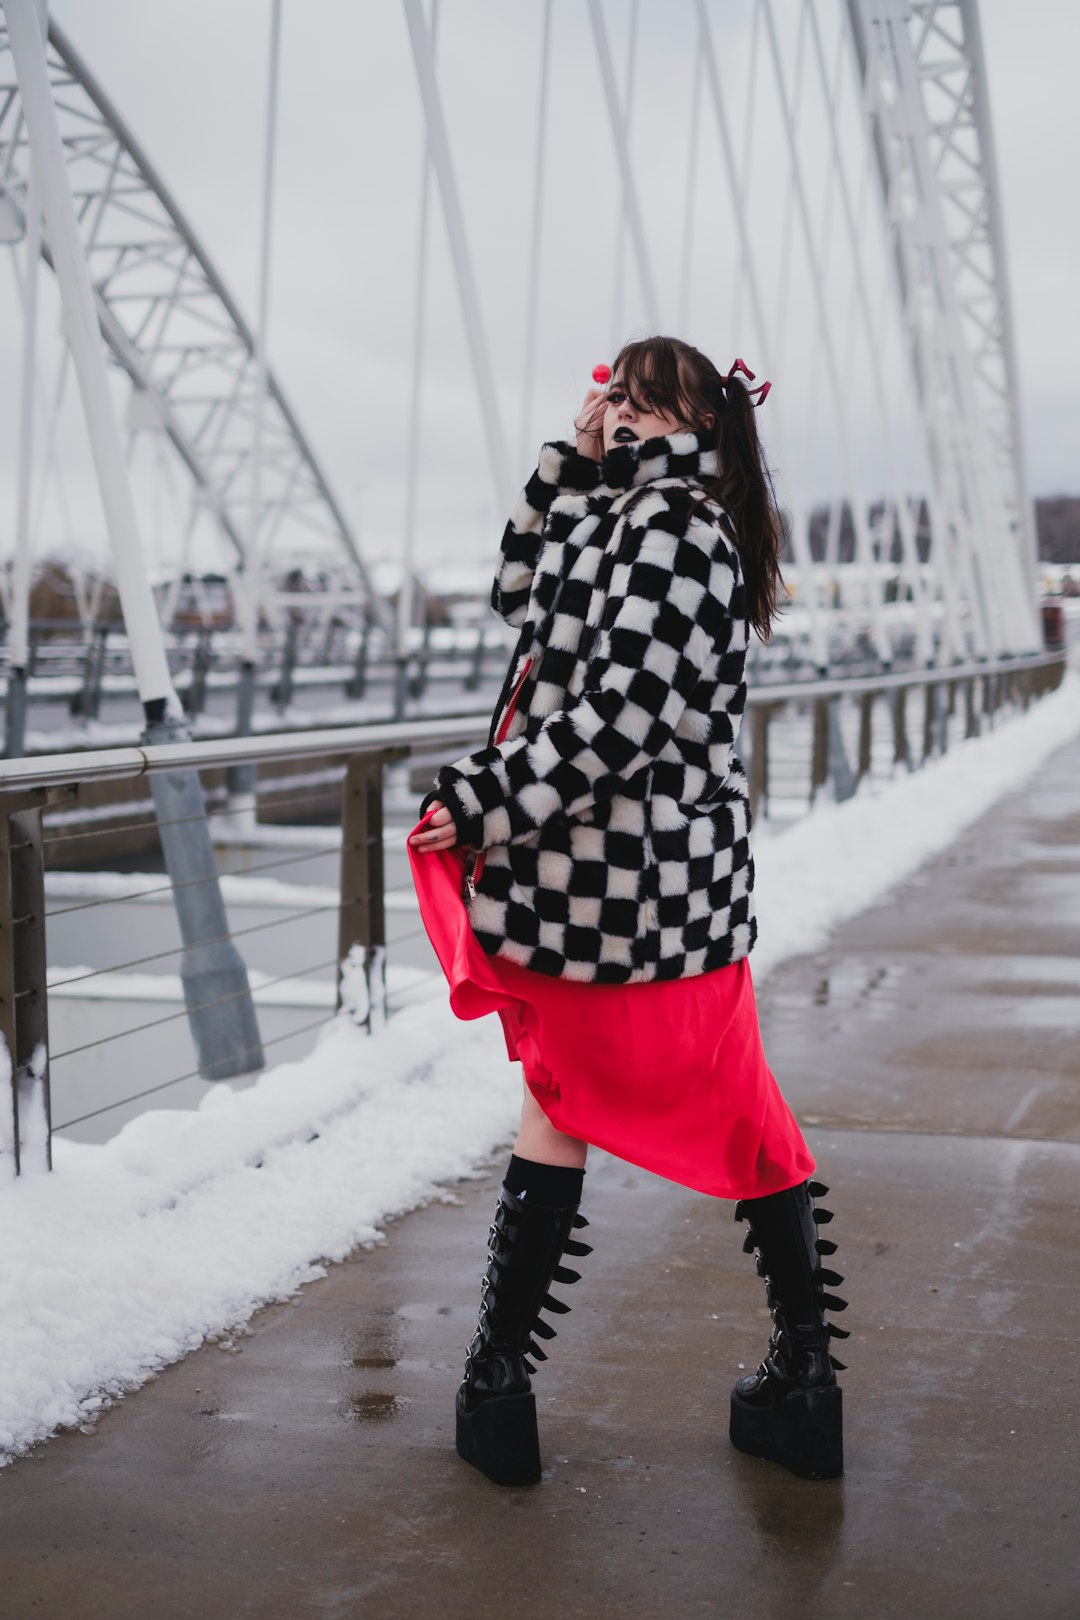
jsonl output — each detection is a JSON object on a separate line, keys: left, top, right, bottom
{"left": 614, "top": 337, "right": 784, "bottom": 642}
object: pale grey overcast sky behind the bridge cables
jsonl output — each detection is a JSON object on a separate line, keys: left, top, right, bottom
{"left": 0, "top": 0, "right": 1080, "bottom": 583}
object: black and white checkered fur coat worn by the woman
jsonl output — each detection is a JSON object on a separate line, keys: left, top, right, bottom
{"left": 426, "top": 433, "right": 756, "bottom": 983}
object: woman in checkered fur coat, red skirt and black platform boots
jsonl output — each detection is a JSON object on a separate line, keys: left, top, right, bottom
{"left": 410, "top": 337, "right": 847, "bottom": 1484}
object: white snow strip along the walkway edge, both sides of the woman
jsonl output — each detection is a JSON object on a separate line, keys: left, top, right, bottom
{"left": 0, "top": 674, "right": 1080, "bottom": 1460}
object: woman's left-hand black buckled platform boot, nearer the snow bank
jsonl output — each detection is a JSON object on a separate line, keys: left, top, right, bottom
{"left": 457, "top": 1187, "right": 593, "bottom": 1486}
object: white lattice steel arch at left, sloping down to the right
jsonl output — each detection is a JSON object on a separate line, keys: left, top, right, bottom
{"left": 0, "top": 21, "right": 385, "bottom": 638}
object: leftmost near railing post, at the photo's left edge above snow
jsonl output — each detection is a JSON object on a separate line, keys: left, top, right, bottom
{"left": 0, "top": 789, "right": 52, "bottom": 1183}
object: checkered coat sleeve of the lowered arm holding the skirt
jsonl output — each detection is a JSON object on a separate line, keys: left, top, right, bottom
{"left": 436, "top": 492, "right": 738, "bottom": 849}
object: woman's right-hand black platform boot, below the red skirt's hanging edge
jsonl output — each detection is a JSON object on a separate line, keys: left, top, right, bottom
{"left": 730, "top": 1181, "right": 848, "bottom": 1479}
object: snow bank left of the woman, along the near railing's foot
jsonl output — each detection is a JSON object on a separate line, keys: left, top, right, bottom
{"left": 0, "top": 972, "right": 520, "bottom": 1461}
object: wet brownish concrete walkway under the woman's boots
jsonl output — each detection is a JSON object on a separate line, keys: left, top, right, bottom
{"left": 0, "top": 744, "right": 1080, "bottom": 1620}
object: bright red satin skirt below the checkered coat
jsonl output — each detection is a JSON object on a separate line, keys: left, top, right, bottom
{"left": 408, "top": 816, "right": 814, "bottom": 1199}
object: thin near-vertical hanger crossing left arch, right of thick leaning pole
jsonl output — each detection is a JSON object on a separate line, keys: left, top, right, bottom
{"left": 228, "top": 0, "right": 282, "bottom": 787}
